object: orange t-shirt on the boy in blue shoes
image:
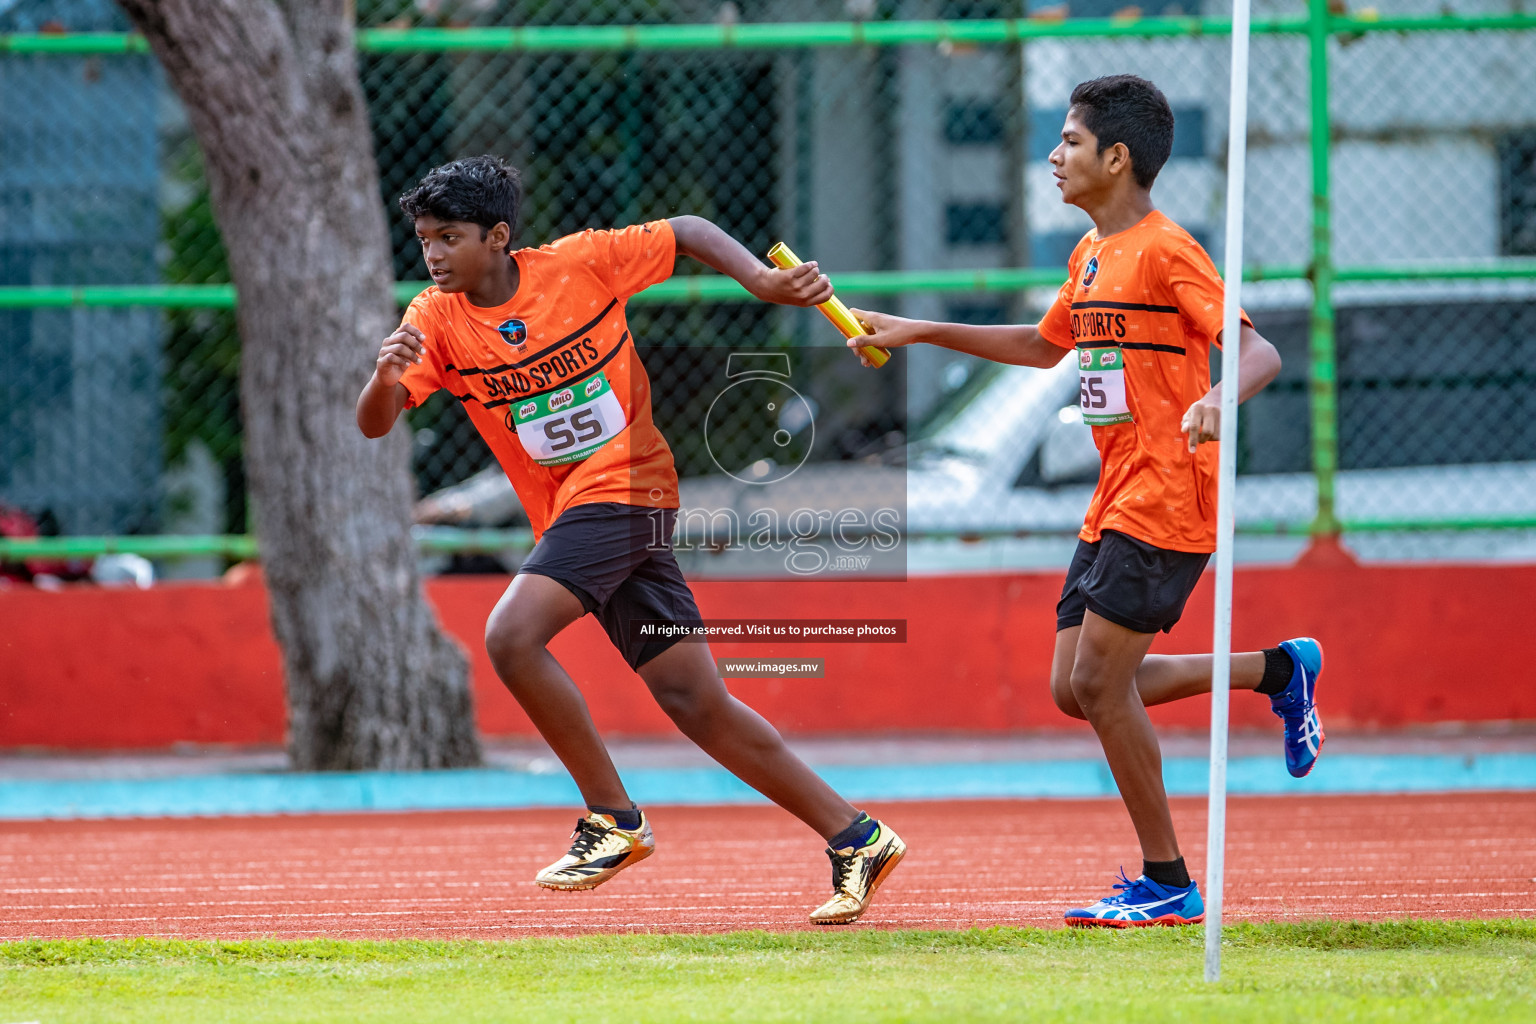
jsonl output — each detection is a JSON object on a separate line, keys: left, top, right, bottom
{"left": 1040, "top": 210, "right": 1252, "bottom": 553}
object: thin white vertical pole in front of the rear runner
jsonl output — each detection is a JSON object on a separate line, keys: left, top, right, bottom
{"left": 1206, "top": 0, "right": 1249, "bottom": 981}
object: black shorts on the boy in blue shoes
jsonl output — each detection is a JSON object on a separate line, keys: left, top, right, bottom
{"left": 1057, "top": 530, "right": 1210, "bottom": 633}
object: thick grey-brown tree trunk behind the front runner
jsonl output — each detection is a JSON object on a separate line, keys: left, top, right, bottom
{"left": 120, "top": 0, "right": 479, "bottom": 769}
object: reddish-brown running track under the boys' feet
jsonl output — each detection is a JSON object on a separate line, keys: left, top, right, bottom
{"left": 0, "top": 792, "right": 1536, "bottom": 940}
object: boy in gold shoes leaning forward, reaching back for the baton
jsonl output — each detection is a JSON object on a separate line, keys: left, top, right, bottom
{"left": 356, "top": 157, "right": 906, "bottom": 924}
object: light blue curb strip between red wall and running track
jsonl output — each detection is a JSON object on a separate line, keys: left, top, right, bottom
{"left": 0, "top": 754, "right": 1536, "bottom": 820}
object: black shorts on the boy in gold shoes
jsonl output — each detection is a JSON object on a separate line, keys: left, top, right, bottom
{"left": 518, "top": 502, "right": 703, "bottom": 668}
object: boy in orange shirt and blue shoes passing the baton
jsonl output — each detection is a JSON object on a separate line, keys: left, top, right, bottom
{"left": 849, "top": 75, "right": 1322, "bottom": 927}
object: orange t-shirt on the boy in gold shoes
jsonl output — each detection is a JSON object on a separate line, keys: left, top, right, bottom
{"left": 401, "top": 221, "right": 677, "bottom": 537}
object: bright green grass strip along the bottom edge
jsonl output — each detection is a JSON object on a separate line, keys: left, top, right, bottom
{"left": 0, "top": 921, "right": 1536, "bottom": 1024}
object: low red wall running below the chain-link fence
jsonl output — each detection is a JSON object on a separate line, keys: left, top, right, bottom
{"left": 0, "top": 565, "right": 1536, "bottom": 749}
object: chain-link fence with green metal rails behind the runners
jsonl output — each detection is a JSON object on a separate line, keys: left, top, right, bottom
{"left": 0, "top": 0, "right": 1536, "bottom": 577}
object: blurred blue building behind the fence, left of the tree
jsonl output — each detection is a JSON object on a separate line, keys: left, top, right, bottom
{"left": 0, "top": 0, "right": 163, "bottom": 533}
